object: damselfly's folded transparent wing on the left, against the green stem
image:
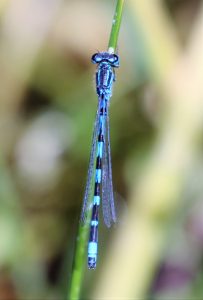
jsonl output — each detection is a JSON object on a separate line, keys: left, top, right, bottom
{"left": 80, "top": 105, "right": 100, "bottom": 223}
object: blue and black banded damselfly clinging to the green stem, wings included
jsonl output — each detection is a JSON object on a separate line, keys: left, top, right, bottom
{"left": 81, "top": 52, "right": 119, "bottom": 269}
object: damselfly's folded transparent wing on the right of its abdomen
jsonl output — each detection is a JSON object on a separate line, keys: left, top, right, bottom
{"left": 102, "top": 99, "right": 116, "bottom": 227}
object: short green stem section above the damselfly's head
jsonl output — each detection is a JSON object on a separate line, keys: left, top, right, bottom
{"left": 108, "top": 0, "right": 124, "bottom": 52}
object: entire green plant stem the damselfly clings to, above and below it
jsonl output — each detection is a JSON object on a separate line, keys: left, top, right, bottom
{"left": 68, "top": 0, "right": 124, "bottom": 300}
